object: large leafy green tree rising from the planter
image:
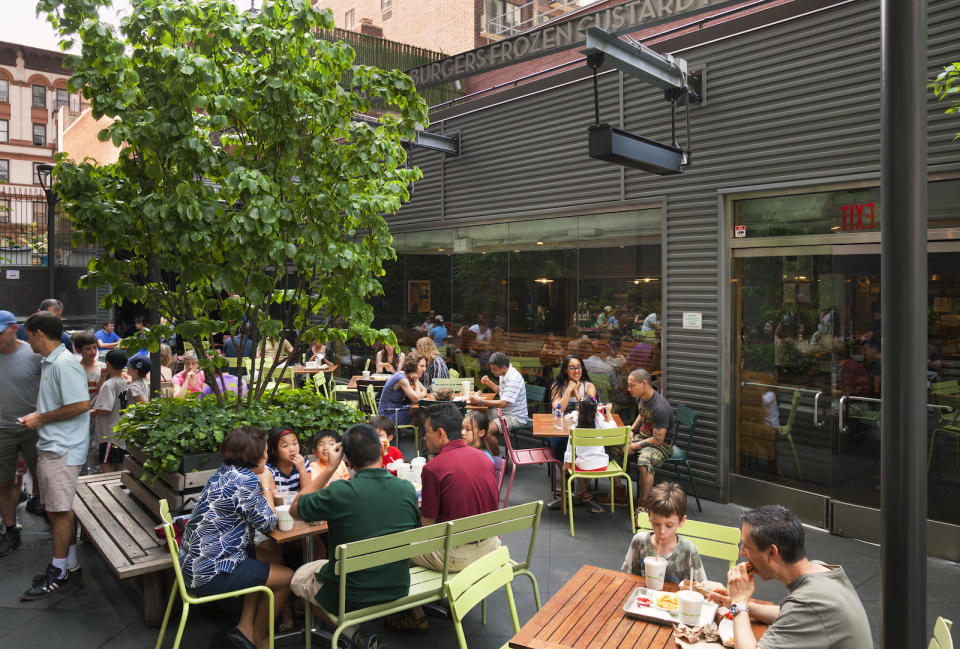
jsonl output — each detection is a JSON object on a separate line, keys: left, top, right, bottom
{"left": 37, "top": 0, "right": 427, "bottom": 399}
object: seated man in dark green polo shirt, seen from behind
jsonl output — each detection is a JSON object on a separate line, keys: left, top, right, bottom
{"left": 290, "top": 424, "right": 420, "bottom": 640}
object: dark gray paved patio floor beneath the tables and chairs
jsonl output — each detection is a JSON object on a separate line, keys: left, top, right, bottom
{"left": 0, "top": 436, "right": 960, "bottom": 649}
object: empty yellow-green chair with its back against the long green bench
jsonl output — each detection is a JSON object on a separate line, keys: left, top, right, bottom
{"left": 443, "top": 546, "right": 520, "bottom": 649}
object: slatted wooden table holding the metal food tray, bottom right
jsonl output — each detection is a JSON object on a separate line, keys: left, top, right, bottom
{"left": 510, "top": 566, "right": 767, "bottom": 649}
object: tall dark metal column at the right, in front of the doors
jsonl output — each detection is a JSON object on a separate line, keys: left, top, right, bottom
{"left": 880, "top": 0, "right": 927, "bottom": 649}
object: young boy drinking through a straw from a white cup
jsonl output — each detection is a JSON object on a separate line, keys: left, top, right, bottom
{"left": 620, "top": 482, "right": 707, "bottom": 583}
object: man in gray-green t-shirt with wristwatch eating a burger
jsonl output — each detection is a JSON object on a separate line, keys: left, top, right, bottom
{"left": 710, "top": 505, "right": 873, "bottom": 649}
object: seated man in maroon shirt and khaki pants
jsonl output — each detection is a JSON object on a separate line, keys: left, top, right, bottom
{"left": 413, "top": 404, "right": 500, "bottom": 572}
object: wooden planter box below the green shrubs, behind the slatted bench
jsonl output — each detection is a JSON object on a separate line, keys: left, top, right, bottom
{"left": 120, "top": 444, "right": 220, "bottom": 517}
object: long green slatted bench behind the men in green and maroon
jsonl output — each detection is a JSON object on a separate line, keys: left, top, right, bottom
{"left": 314, "top": 501, "right": 543, "bottom": 649}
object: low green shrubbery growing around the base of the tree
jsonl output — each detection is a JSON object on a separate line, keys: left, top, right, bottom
{"left": 117, "top": 388, "right": 363, "bottom": 475}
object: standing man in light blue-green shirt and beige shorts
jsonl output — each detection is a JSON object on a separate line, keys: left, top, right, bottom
{"left": 20, "top": 312, "right": 90, "bottom": 600}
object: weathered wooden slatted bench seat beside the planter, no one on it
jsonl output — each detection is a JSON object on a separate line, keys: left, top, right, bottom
{"left": 73, "top": 473, "right": 173, "bottom": 627}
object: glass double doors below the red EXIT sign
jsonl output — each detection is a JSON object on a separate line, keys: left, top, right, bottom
{"left": 732, "top": 243, "right": 960, "bottom": 524}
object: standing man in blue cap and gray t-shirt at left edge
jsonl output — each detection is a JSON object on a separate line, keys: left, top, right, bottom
{"left": 0, "top": 311, "right": 40, "bottom": 557}
